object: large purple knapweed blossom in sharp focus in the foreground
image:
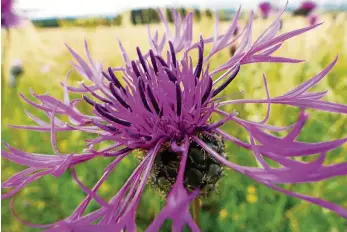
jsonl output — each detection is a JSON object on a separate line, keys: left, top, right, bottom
{"left": 2, "top": 6, "right": 347, "bottom": 232}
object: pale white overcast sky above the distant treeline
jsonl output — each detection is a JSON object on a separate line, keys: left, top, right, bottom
{"left": 15, "top": 0, "right": 347, "bottom": 18}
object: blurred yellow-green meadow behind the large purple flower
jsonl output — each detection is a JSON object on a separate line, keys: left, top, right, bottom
{"left": 1, "top": 8, "right": 347, "bottom": 232}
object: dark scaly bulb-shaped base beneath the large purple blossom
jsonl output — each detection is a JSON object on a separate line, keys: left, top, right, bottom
{"left": 151, "top": 134, "right": 226, "bottom": 196}
